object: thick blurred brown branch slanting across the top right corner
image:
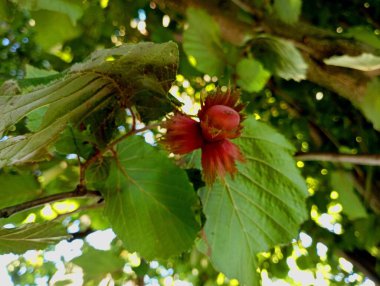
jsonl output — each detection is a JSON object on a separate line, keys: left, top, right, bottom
{"left": 155, "top": 0, "right": 380, "bottom": 103}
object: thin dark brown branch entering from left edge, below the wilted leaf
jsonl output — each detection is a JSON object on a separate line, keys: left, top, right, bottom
{"left": 0, "top": 187, "right": 102, "bottom": 218}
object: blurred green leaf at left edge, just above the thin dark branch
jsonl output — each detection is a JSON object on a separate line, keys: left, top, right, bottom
{"left": 0, "top": 173, "right": 42, "bottom": 208}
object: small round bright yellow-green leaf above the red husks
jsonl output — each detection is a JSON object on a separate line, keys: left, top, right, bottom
{"left": 236, "top": 59, "right": 270, "bottom": 92}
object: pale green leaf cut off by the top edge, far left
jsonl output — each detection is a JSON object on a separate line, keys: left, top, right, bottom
{"left": 14, "top": 0, "right": 83, "bottom": 25}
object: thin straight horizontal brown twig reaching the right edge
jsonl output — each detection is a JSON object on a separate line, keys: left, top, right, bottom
{"left": 295, "top": 153, "right": 380, "bottom": 166}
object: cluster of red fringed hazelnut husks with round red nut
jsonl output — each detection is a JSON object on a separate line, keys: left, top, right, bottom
{"left": 164, "top": 90, "right": 244, "bottom": 185}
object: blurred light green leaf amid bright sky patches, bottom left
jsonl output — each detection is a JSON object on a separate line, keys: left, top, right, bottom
{"left": 72, "top": 247, "right": 125, "bottom": 283}
